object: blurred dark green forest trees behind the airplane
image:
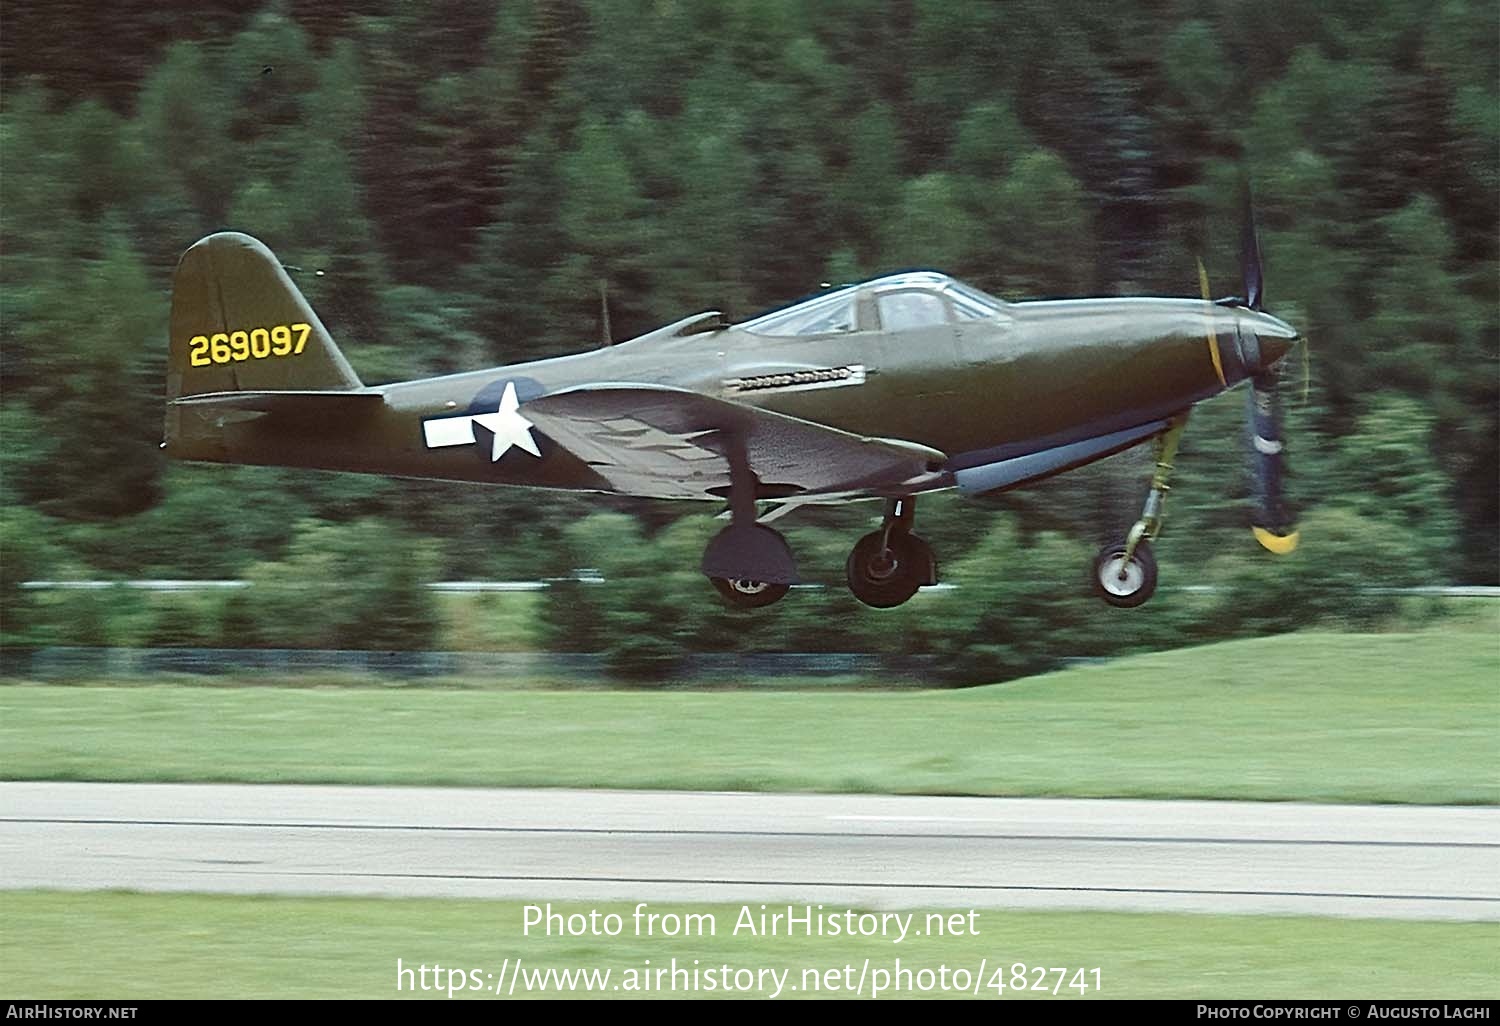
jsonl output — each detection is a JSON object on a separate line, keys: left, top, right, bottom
{"left": 0, "top": 0, "right": 1500, "bottom": 683}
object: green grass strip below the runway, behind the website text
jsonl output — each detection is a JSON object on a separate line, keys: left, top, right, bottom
{"left": 0, "top": 893, "right": 1500, "bottom": 1001}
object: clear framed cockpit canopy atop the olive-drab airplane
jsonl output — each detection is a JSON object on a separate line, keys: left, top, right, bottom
{"left": 738, "top": 272, "right": 1005, "bottom": 338}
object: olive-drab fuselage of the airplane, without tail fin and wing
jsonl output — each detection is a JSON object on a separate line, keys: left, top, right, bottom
{"left": 174, "top": 274, "right": 1296, "bottom": 491}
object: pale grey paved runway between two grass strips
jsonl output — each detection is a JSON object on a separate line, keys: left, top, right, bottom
{"left": 0, "top": 783, "right": 1500, "bottom": 921}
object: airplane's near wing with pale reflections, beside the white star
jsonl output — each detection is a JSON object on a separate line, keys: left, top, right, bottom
{"left": 521, "top": 384, "right": 947, "bottom": 498}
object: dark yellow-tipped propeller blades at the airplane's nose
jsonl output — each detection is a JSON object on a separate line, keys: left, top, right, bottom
{"left": 1239, "top": 180, "right": 1299, "bottom": 555}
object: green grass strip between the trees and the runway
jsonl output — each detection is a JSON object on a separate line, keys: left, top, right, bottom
{"left": 0, "top": 633, "right": 1500, "bottom": 804}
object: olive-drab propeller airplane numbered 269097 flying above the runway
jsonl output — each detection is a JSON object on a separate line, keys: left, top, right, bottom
{"left": 162, "top": 207, "right": 1301, "bottom": 609}
